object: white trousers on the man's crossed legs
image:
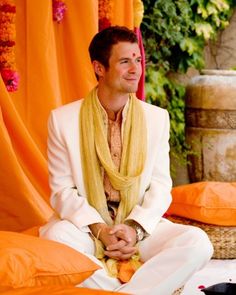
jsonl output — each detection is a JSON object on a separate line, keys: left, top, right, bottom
{"left": 40, "top": 220, "right": 213, "bottom": 295}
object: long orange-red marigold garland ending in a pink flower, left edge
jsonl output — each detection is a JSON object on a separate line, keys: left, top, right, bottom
{"left": 0, "top": 0, "right": 19, "bottom": 92}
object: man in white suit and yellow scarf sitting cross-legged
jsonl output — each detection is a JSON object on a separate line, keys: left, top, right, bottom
{"left": 41, "top": 26, "right": 212, "bottom": 295}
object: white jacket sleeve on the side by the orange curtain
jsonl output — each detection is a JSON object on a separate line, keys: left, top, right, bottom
{"left": 48, "top": 111, "right": 104, "bottom": 231}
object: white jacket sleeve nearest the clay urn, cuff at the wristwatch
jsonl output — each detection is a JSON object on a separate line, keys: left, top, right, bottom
{"left": 124, "top": 111, "right": 172, "bottom": 234}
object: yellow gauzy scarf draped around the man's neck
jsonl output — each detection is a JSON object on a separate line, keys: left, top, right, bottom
{"left": 80, "top": 88, "right": 147, "bottom": 282}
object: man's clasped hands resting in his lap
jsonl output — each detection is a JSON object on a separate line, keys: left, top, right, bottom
{"left": 90, "top": 223, "right": 137, "bottom": 260}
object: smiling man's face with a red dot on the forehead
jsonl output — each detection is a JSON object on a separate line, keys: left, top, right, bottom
{"left": 102, "top": 42, "right": 142, "bottom": 94}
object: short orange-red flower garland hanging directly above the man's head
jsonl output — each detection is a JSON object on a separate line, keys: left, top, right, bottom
{"left": 98, "top": 0, "right": 113, "bottom": 31}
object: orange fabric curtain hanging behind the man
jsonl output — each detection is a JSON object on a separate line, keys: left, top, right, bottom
{"left": 0, "top": 0, "right": 134, "bottom": 231}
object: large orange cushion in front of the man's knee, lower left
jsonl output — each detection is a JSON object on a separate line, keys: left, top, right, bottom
{"left": 0, "top": 231, "right": 100, "bottom": 288}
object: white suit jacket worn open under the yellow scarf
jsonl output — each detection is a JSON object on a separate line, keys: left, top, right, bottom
{"left": 48, "top": 100, "right": 172, "bottom": 234}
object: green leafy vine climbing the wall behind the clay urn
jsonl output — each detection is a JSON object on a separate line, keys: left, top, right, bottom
{"left": 141, "top": 0, "right": 236, "bottom": 175}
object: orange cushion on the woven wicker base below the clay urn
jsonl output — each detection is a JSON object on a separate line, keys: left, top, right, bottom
{"left": 167, "top": 182, "right": 236, "bottom": 226}
